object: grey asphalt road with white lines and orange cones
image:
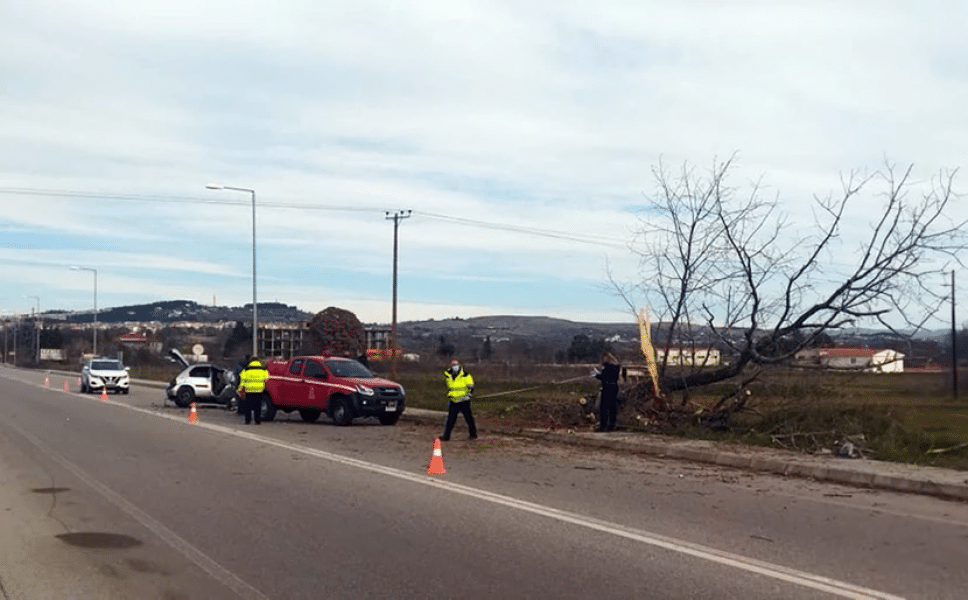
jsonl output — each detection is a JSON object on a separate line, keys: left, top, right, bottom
{"left": 0, "top": 369, "right": 968, "bottom": 600}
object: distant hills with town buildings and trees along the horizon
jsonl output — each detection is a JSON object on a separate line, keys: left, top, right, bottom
{"left": 2, "top": 301, "right": 964, "bottom": 373}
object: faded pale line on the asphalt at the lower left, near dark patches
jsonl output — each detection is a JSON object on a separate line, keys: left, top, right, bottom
{"left": 5, "top": 420, "right": 269, "bottom": 600}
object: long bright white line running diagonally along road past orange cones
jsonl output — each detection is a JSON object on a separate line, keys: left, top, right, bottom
{"left": 13, "top": 376, "right": 904, "bottom": 600}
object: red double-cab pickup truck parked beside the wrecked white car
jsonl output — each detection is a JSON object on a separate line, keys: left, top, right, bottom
{"left": 262, "top": 356, "right": 407, "bottom": 425}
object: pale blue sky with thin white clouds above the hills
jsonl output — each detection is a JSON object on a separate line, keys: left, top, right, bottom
{"left": 0, "top": 0, "right": 968, "bottom": 323}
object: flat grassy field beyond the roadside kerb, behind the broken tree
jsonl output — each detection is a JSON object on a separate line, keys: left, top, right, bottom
{"left": 132, "top": 364, "right": 968, "bottom": 470}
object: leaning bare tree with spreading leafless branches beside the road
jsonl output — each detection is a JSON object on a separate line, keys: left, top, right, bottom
{"left": 613, "top": 158, "right": 966, "bottom": 410}
